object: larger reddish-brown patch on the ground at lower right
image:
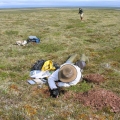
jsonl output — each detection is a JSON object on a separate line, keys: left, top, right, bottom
{"left": 64, "top": 88, "right": 120, "bottom": 112}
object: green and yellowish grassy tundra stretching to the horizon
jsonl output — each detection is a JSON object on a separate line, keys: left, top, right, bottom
{"left": 0, "top": 8, "right": 120, "bottom": 120}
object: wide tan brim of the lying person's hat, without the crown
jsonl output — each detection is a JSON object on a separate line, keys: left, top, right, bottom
{"left": 58, "top": 64, "right": 77, "bottom": 82}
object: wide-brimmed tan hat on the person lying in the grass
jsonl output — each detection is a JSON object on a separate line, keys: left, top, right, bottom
{"left": 58, "top": 64, "right": 77, "bottom": 82}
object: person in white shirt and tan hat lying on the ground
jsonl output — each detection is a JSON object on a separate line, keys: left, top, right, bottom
{"left": 48, "top": 54, "right": 87, "bottom": 98}
